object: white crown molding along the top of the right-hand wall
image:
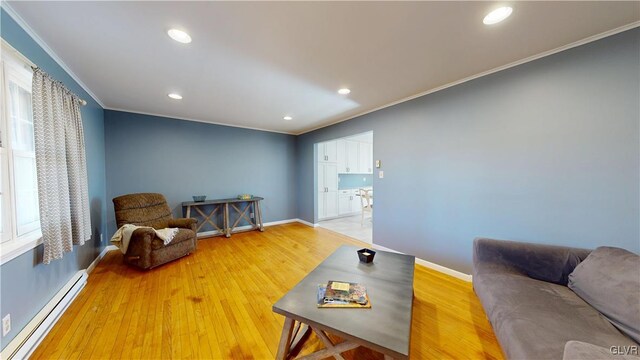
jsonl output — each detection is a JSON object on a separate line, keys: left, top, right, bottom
{"left": 295, "top": 21, "right": 640, "bottom": 135}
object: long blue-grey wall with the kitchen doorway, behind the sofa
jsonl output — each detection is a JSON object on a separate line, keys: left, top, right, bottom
{"left": 297, "top": 29, "right": 640, "bottom": 273}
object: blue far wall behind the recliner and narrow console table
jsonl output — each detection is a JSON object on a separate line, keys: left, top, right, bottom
{"left": 105, "top": 110, "right": 297, "bottom": 235}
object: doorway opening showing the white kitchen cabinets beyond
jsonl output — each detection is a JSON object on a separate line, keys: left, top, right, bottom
{"left": 316, "top": 131, "right": 374, "bottom": 244}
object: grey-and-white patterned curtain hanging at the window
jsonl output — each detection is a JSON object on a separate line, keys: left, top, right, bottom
{"left": 32, "top": 69, "right": 91, "bottom": 264}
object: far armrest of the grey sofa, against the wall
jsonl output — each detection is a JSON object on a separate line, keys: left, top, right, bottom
{"left": 473, "top": 238, "right": 591, "bottom": 285}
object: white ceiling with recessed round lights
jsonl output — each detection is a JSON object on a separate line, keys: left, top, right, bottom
{"left": 9, "top": 1, "right": 640, "bottom": 134}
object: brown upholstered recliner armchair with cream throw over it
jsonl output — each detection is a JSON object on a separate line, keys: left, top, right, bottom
{"left": 113, "top": 193, "right": 197, "bottom": 269}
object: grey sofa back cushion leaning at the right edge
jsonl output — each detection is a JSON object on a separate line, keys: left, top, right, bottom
{"left": 569, "top": 247, "right": 640, "bottom": 342}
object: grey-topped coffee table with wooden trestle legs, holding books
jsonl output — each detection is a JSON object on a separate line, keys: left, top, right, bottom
{"left": 273, "top": 246, "right": 415, "bottom": 359}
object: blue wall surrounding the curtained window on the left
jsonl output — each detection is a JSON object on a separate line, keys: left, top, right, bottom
{"left": 0, "top": 9, "right": 107, "bottom": 349}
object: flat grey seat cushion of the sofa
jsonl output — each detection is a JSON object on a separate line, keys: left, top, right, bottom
{"left": 473, "top": 273, "right": 635, "bottom": 359}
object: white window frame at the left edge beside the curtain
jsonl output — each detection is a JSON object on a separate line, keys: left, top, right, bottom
{"left": 0, "top": 39, "right": 42, "bottom": 265}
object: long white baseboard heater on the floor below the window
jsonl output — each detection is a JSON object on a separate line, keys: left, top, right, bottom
{"left": 0, "top": 270, "right": 88, "bottom": 360}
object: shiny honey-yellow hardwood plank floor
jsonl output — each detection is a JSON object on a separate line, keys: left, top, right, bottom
{"left": 32, "top": 224, "right": 502, "bottom": 359}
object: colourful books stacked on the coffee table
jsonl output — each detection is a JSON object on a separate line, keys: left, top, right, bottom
{"left": 318, "top": 280, "right": 371, "bottom": 308}
